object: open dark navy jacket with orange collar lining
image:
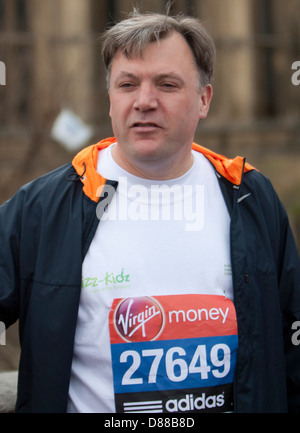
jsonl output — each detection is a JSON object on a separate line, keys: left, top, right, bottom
{"left": 0, "top": 139, "right": 300, "bottom": 413}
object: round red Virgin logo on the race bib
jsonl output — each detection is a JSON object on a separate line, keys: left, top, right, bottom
{"left": 114, "top": 297, "right": 165, "bottom": 343}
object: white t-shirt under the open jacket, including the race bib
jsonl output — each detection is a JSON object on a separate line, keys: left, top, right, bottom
{"left": 68, "top": 147, "right": 236, "bottom": 413}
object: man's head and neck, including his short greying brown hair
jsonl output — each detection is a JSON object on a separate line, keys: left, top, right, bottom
{"left": 103, "top": 13, "right": 215, "bottom": 180}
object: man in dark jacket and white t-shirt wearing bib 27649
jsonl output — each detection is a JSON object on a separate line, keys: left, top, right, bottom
{"left": 0, "top": 13, "right": 300, "bottom": 414}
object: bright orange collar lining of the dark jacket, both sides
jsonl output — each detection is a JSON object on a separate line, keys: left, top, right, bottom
{"left": 72, "top": 137, "right": 255, "bottom": 202}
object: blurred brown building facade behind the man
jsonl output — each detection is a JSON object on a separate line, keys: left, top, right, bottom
{"left": 0, "top": 0, "right": 300, "bottom": 237}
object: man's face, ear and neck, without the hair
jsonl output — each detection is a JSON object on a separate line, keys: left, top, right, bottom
{"left": 109, "top": 33, "right": 212, "bottom": 178}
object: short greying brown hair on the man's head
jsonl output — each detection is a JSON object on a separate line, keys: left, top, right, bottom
{"left": 102, "top": 10, "right": 216, "bottom": 87}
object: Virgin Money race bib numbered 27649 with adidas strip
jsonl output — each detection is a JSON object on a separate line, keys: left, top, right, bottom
{"left": 109, "top": 295, "right": 238, "bottom": 413}
